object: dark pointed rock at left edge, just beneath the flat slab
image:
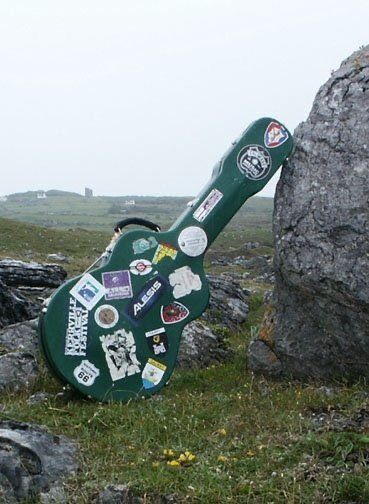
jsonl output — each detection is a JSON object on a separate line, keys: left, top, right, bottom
{"left": 0, "top": 278, "right": 39, "bottom": 328}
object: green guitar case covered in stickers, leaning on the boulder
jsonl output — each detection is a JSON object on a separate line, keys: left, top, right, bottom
{"left": 39, "top": 118, "right": 293, "bottom": 401}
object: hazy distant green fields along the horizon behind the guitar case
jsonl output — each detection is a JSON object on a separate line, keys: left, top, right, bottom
{"left": 0, "top": 191, "right": 273, "bottom": 251}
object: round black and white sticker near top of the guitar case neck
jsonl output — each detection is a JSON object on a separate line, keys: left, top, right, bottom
{"left": 237, "top": 145, "right": 272, "bottom": 180}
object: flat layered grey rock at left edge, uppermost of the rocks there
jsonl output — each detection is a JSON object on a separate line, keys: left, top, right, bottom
{"left": 0, "top": 259, "right": 67, "bottom": 287}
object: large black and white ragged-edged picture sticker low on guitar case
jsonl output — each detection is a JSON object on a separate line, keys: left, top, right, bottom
{"left": 100, "top": 329, "right": 140, "bottom": 381}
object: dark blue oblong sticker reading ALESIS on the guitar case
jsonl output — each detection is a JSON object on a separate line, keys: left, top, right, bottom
{"left": 125, "top": 275, "right": 168, "bottom": 322}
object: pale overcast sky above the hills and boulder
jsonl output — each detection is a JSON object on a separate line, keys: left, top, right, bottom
{"left": 0, "top": 0, "right": 369, "bottom": 195}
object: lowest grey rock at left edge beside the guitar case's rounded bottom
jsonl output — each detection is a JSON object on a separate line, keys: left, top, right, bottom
{"left": 0, "top": 352, "right": 39, "bottom": 393}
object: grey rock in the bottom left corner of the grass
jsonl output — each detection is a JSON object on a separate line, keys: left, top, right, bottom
{"left": 0, "top": 421, "right": 78, "bottom": 503}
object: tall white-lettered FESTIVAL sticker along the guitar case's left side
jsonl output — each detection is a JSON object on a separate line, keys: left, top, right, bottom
{"left": 64, "top": 297, "right": 88, "bottom": 357}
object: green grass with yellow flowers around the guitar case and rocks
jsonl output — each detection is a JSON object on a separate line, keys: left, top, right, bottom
{"left": 0, "top": 219, "right": 369, "bottom": 504}
